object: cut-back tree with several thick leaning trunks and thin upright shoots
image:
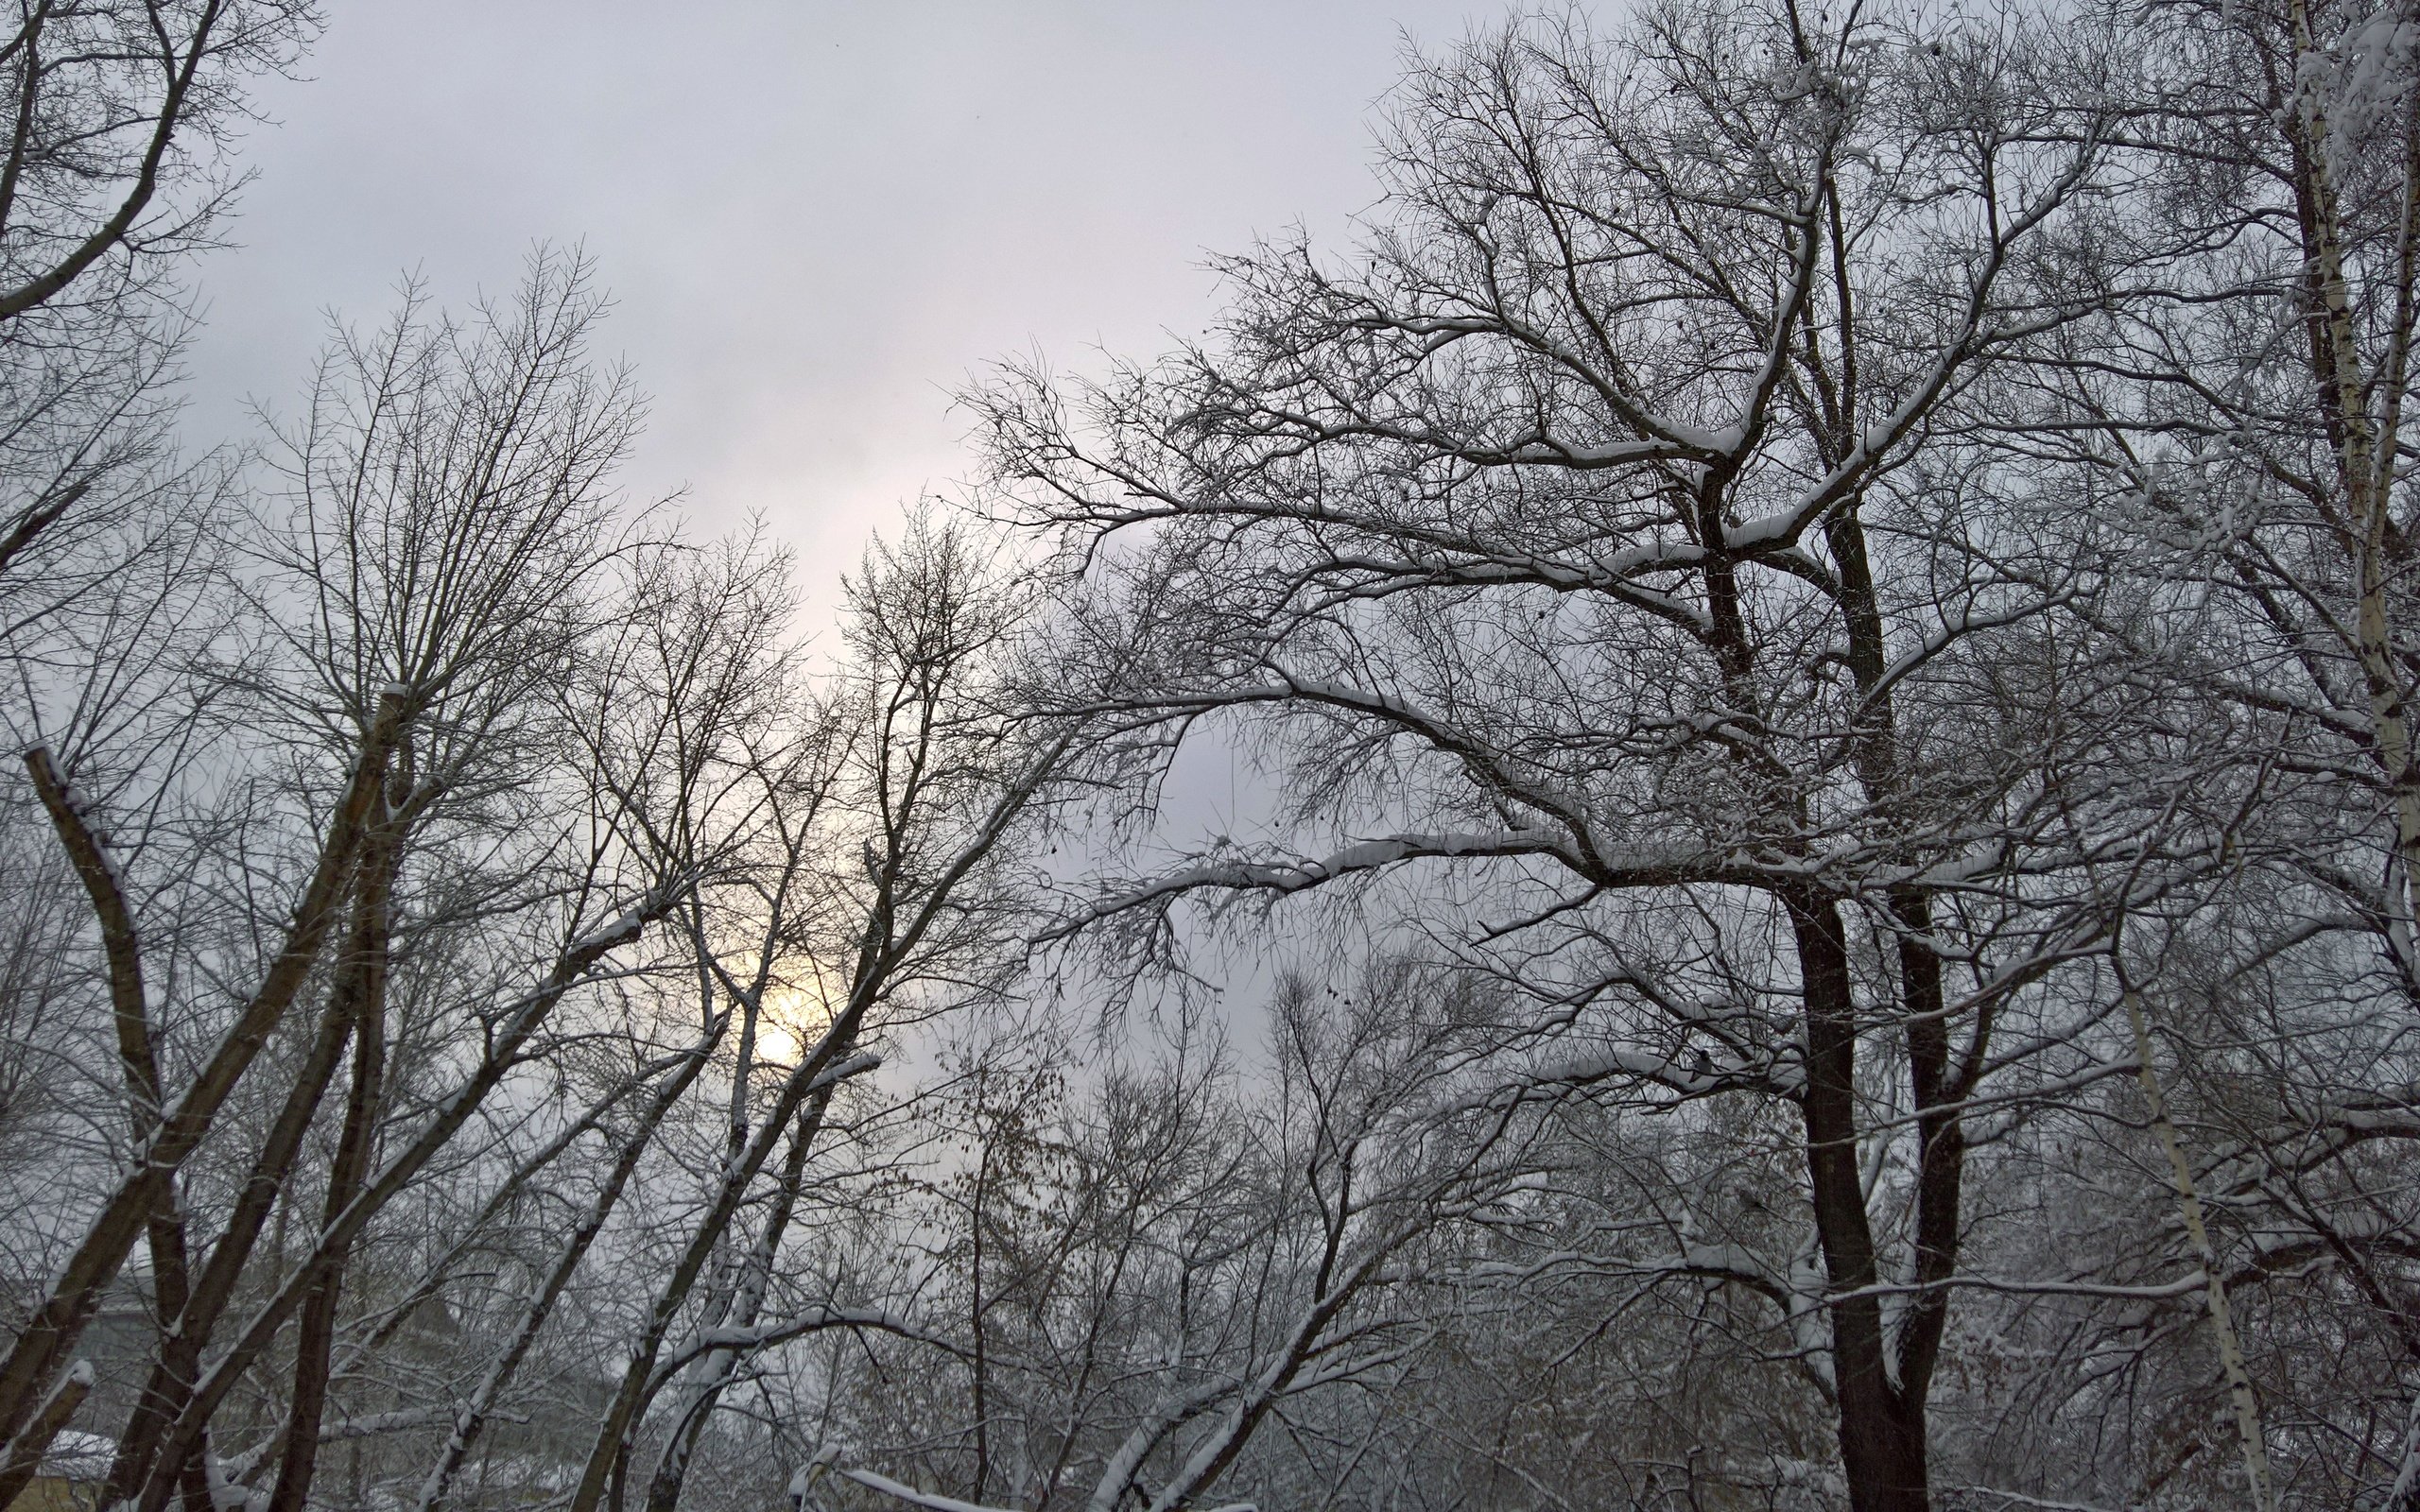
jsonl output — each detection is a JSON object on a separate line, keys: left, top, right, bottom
{"left": 0, "top": 259, "right": 706, "bottom": 1504}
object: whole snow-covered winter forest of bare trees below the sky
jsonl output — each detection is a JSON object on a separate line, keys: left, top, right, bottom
{"left": 0, "top": 0, "right": 2420, "bottom": 1512}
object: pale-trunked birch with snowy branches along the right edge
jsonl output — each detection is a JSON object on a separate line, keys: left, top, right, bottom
{"left": 2038, "top": 0, "right": 2420, "bottom": 1504}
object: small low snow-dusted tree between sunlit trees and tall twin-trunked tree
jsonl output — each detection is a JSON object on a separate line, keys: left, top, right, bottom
{"left": 799, "top": 960, "right": 1537, "bottom": 1509}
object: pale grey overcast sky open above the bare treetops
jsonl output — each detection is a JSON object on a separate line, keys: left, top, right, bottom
{"left": 191, "top": 0, "right": 1503, "bottom": 597}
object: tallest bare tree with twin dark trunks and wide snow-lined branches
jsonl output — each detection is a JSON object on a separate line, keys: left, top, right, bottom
{"left": 976, "top": 5, "right": 2168, "bottom": 1509}
